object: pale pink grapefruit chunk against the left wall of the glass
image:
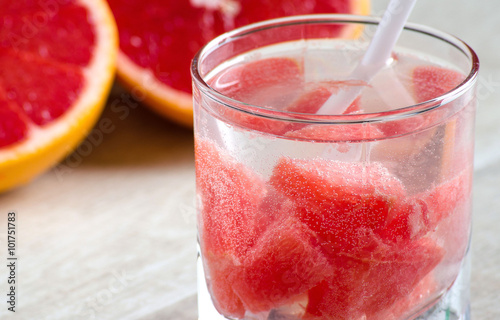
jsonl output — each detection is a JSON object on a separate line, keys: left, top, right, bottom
{"left": 195, "top": 140, "right": 266, "bottom": 256}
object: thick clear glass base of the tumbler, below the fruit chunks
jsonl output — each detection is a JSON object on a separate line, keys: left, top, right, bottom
{"left": 198, "top": 253, "right": 471, "bottom": 320}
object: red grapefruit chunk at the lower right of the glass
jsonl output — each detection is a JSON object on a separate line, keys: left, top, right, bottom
{"left": 304, "top": 239, "right": 443, "bottom": 320}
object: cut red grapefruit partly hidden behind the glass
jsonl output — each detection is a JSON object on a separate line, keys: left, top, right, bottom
{"left": 108, "top": 0, "right": 369, "bottom": 127}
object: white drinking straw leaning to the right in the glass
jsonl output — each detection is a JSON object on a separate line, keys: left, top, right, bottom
{"left": 317, "top": 0, "right": 417, "bottom": 115}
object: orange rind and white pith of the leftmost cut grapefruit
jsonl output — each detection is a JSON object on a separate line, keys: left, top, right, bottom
{"left": 0, "top": 0, "right": 118, "bottom": 192}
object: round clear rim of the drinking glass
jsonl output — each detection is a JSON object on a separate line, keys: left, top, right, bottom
{"left": 191, "top": 13, "right": 479, "bottom": 124}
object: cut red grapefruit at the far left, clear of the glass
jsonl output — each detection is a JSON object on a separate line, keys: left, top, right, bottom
{"left": 0, "top": 0, "right": 118, "bottom": 191}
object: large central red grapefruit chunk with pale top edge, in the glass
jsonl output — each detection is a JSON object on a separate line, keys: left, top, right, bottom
{"left": 270, "top": 158, "right": 418, "bottom": 251}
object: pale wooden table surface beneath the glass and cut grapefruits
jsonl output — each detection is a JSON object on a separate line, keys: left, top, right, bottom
{"left": 0, "top": 0, "right": 500, "bottom": 320}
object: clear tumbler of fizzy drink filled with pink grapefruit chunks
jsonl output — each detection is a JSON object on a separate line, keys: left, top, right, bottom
{"left": 193, "top": 16, "right": 477, "bottom": 320}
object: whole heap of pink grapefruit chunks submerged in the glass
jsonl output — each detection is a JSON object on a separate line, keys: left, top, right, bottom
{"left": 196, "top": 139, "right": 454, "bottom": 320}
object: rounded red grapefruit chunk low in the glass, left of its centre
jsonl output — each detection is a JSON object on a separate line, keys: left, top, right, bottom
{"left": 233, "top": 218, "right": 330, "bottom": 313}
